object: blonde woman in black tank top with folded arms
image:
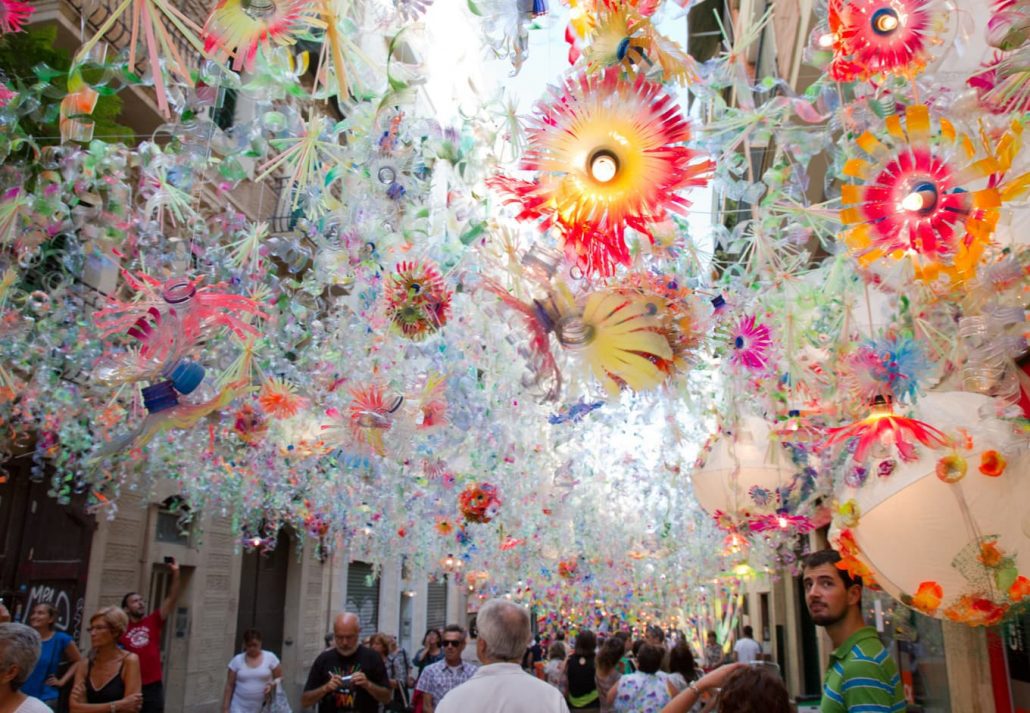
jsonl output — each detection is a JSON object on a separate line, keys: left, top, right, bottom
{"left": 70, "top": 607, "right": 143, "bottom": 713}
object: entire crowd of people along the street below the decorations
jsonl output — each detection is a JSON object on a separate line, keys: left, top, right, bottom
{"left": 0, "top": 550, "right": 905, "bottom": 713}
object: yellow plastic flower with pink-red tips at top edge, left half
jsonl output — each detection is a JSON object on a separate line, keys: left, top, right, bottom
{"left": 203, "top": 0, "right": 325, "bottom": 72}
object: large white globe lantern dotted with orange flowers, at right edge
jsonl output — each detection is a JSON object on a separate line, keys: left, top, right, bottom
{"left": 830, "top": 393, "right": 1030, "bottom": 625}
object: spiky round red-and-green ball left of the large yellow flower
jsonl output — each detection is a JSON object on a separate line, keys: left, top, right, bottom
{"left": 383, "top": 261, "right": 451, "bottom": 341}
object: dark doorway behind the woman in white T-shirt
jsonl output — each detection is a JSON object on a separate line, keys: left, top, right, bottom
{"left": 235, "top": 530, "right": 294, "bottom": 658}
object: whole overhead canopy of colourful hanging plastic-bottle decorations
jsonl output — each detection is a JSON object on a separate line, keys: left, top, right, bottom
{"left": 0, "top": 0, "right": 1030, "bottom": 626}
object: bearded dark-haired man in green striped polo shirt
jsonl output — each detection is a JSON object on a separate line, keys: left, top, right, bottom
{"left": 802, "top": 549, "right": 906, "bottom": 713}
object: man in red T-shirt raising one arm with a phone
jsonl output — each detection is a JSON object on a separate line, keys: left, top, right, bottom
{"left": 118, "top": 557, "right": 179, "bottom": 713}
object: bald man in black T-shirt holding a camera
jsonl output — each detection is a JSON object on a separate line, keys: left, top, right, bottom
{"left": 301, "top": 614, "right": 392, "bottom": 713}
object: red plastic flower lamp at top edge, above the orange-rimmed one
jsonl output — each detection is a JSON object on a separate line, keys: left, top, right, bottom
{"left": 817, "top": 0, "right": 949, "bottom": 81}
